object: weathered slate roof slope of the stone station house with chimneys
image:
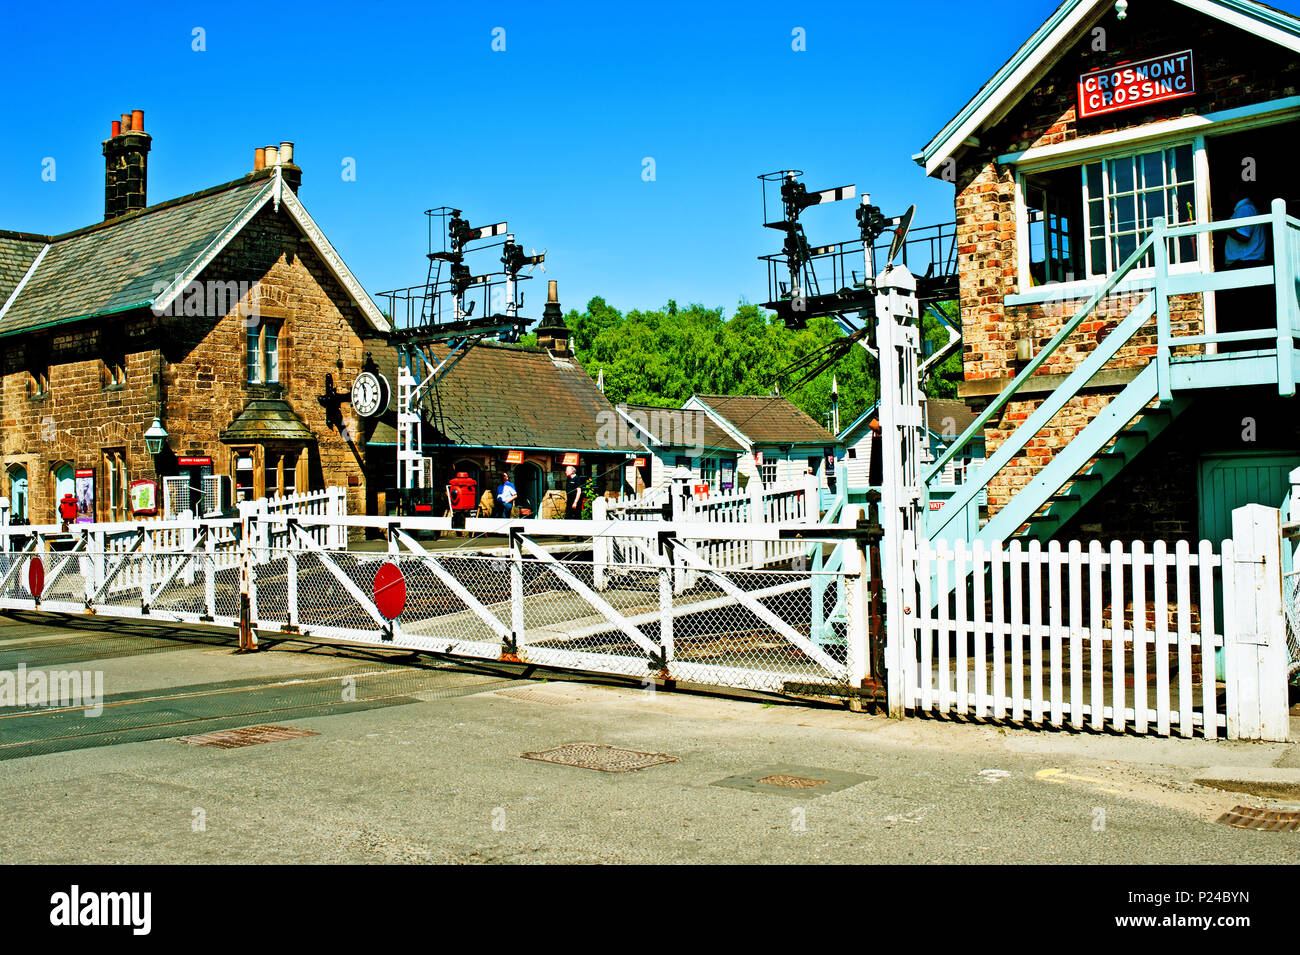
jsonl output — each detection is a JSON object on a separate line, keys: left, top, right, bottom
{"left": 0, "top": 172, "right": 273, "bottom": 338}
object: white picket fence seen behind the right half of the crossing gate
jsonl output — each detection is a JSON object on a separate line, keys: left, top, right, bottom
{"left": 592, "top": 479, "right": 819, "bottom": 570}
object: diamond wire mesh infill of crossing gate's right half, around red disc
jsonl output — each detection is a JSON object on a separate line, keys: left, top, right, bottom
{"left": 245, "top": 550, "right": 846, "bottom": 690}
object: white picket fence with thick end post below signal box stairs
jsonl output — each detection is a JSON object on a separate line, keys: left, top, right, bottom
{"left": 891, "top": 505, "right": 1287, "bottom": 738}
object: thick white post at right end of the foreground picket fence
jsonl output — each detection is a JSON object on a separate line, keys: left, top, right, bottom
{"left": 1222, "top": 504, "right": 1291, "bottom": 742}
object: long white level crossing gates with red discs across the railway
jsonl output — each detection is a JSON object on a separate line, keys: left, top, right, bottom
{"left": 0, "top": 513, "right": 866, "bottom": 696}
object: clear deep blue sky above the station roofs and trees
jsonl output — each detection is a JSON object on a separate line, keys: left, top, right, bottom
{"left": 0, "top": 0, "right": 1107, "bottom": 317}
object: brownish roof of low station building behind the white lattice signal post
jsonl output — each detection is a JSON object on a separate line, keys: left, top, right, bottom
{"left": 367, "top": 340, "right": 641, "bottom": 451}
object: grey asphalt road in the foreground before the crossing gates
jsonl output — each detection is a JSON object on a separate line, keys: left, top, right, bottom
{"left": 0, "top": 616, "right": 1300, "bottom": 864}
